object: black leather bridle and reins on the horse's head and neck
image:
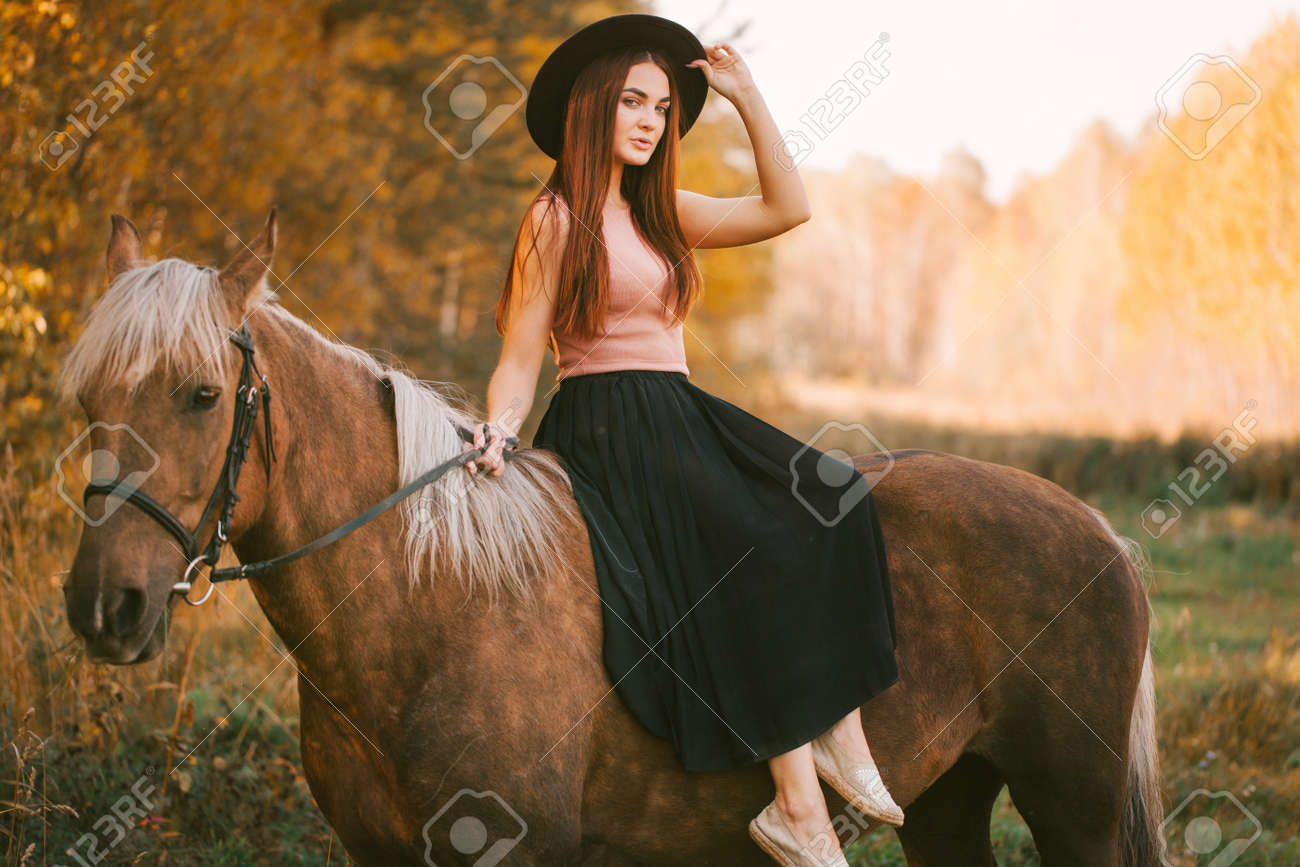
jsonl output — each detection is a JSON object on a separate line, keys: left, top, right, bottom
{"left": 82, "top": 322, "right": 519, "bottom": 606}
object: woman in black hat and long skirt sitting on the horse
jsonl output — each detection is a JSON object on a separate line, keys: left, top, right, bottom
{"left": 465, "top": 14, "right": 902, "bottom": 867}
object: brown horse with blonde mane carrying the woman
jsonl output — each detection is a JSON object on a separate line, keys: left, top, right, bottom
{"left": 60, "top": 209, "right": 1164, "bottom": 866}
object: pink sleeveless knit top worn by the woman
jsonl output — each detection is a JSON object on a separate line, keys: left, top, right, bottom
{"left": 551, "top": 205, "right": 690, "bottom": 382}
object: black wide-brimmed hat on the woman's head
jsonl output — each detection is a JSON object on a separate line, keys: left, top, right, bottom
{"left": 524, "top": 13, "right": 709, "bottom": 160}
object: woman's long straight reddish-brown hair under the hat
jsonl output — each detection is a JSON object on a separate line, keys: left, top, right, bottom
{"left": 497, "top": 48, "right": 703, "bottom": 338}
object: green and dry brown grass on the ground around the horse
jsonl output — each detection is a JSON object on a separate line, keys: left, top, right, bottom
{"left": 0, "top": 436, "right": 1300, "bottom": 867}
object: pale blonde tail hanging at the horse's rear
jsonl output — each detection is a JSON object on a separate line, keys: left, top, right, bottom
{"left": 1088, "top": 506, "right": 1169, "bottom": 867}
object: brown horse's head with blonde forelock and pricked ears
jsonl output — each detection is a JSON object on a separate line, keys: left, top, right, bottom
{"left": 60, "top": 209, "right": 276, "bottom": 664}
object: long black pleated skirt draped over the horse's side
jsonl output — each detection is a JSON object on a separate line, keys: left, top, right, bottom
{"left": 533, "top": 369, "right": 898, "bottom": 771}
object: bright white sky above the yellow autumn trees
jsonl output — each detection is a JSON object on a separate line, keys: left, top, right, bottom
{"left": 657, "top": 0, "right": 1300, "bottom": 201}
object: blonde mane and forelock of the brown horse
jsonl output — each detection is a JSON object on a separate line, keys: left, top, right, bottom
{"left": 60, "top": 259, "right": 584, "bottom": 604}
